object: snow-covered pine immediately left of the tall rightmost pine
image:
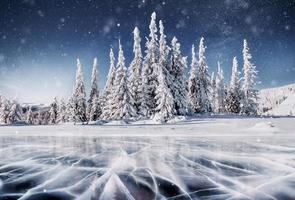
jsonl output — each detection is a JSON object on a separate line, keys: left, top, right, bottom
{"left": 225, "top": 57, "right": 241, "bottom": 114}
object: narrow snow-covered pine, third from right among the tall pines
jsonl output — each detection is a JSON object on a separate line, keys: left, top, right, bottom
{"left": 214, "top": 62, "right": 225, "bottom": 113}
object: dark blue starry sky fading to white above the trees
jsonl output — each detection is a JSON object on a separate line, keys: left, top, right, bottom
{"left": 0, "top": 0, "right": 295, "bottom": 102}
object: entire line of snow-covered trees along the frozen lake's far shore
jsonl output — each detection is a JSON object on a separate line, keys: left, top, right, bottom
{"left": 0, "top": 13, "right": 257, "bottom": 124}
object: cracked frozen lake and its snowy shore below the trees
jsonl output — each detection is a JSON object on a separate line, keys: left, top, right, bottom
{"left": 0, "top": 118, "right": 295, "bottom": 200}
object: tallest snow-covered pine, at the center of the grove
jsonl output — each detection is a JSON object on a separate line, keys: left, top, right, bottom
{"left": 140, "top": 12, "right": 159, "bottom": 117}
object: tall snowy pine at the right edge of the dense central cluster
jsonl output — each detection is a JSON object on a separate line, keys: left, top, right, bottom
{"left": 197, "top": 37, "right": 212, "bottom": 113}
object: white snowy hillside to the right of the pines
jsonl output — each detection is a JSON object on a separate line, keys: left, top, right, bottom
{"left": 259, "top": 84, "right": 295, "bottom": 116}
